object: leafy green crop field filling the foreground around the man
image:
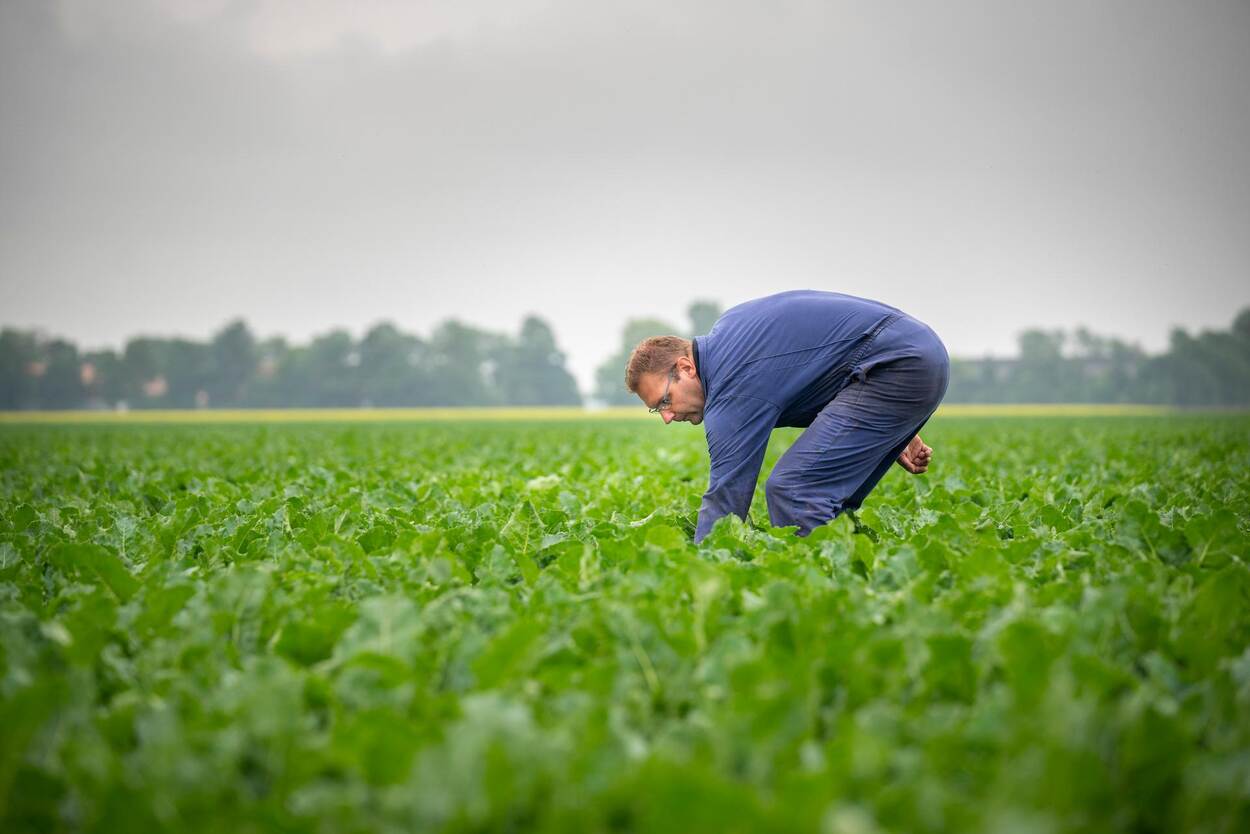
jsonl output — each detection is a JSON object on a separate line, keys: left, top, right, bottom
{"left": 0, "top": 415, "right": 1250, "bottom": 834}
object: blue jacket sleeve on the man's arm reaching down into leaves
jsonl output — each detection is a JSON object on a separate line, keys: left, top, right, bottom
{"left": 695, "top": 396, "right": 780, "bottom": 541}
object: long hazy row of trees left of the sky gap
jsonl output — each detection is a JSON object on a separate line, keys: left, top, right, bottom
{"left": 0, "top": 316, "right": 581, "bottom": 410}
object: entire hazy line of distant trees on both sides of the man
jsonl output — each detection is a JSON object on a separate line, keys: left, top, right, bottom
{"left": 0, "top": 301, "right": 1250, "bottom": 410}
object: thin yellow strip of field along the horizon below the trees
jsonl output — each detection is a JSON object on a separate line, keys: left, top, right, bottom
{"left": 0, "top": 404, "right": 1185, "bottom": 424}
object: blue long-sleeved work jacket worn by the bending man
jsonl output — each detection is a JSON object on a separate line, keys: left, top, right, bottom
{"left": 694, "top": 290, "right": 930, "bottom": 541}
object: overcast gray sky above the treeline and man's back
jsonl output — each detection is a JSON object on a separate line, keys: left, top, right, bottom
{"left": 0, "top": 0, "right": 1250, "bottom": 386}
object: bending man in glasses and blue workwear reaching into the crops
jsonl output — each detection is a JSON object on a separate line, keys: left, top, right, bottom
{"left": 625, "top": 290, "right": 950, "bottom": 541}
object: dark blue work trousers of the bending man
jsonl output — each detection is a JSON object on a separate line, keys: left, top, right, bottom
{"left": 764, "top": 318, "right": 950, "bottom": 535}
